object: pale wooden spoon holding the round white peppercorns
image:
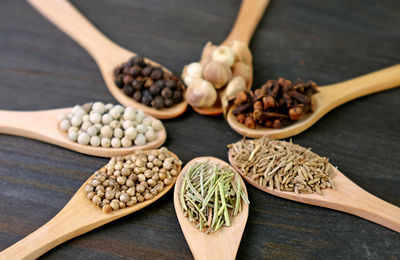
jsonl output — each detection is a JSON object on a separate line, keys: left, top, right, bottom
{"left": 0, "top": 108, "right": 167, "bottom": 157}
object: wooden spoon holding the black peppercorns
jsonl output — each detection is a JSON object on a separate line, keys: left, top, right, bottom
{"left": 28, "top": 0, "right": 187, "bottom": 119}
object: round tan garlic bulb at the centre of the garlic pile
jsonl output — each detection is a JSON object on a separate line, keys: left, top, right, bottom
{"left": 203, "top": 61, "right": 232, "bottom": 89}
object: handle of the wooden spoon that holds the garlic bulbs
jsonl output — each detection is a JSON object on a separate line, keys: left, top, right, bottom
{"left": 223, "top": 0, "right": 270, "bottom": 45}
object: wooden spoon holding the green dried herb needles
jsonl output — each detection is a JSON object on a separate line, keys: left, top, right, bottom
{"left": 174, "top": 157, "right": 249, "bottom": 260}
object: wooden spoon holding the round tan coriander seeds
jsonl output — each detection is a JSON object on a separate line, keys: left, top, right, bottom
{"left": 0, "top": 151, "right": 181, "bottom": 259}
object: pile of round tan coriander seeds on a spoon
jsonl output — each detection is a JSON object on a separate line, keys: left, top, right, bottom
{"left": 85, "top": 147, "right": 182, "bottom": 213}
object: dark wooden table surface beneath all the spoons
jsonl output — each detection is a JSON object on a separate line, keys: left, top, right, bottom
{"left": 0, "top": 0, "right": 400, "bottom": 259}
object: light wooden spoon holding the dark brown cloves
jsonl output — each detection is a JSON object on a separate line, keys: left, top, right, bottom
{"left": 227, "top": 65, "right": 400, "bottom": 139}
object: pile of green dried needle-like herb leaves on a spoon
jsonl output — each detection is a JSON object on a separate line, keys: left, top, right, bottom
{"left": 179, "top": 162, "right": 250, "bottom": 233}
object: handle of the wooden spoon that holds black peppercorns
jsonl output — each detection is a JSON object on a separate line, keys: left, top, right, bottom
{"left": 28, "top": 0, "right": 130, "bottom": 61}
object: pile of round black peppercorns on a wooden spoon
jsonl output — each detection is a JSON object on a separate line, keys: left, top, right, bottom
{"left": 114, "top": 56, "right": 185, "bottom": 109}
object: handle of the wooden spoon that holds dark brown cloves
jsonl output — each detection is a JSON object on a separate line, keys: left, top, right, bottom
{"left": 321, "top": 64, "right": 400, "bottom": 105}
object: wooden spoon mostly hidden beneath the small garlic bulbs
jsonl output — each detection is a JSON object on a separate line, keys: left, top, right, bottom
{"left": 193, "top": 0, "right": 270, "bottom": 116}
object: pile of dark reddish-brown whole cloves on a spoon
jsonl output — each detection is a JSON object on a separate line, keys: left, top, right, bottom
{"left": 232, "top": 78, "right": 318, "bottom": 128}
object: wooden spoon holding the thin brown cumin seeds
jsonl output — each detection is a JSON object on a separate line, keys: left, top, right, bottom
{"left": 229, "top": 150, "right": 400, "bottom": 232}
